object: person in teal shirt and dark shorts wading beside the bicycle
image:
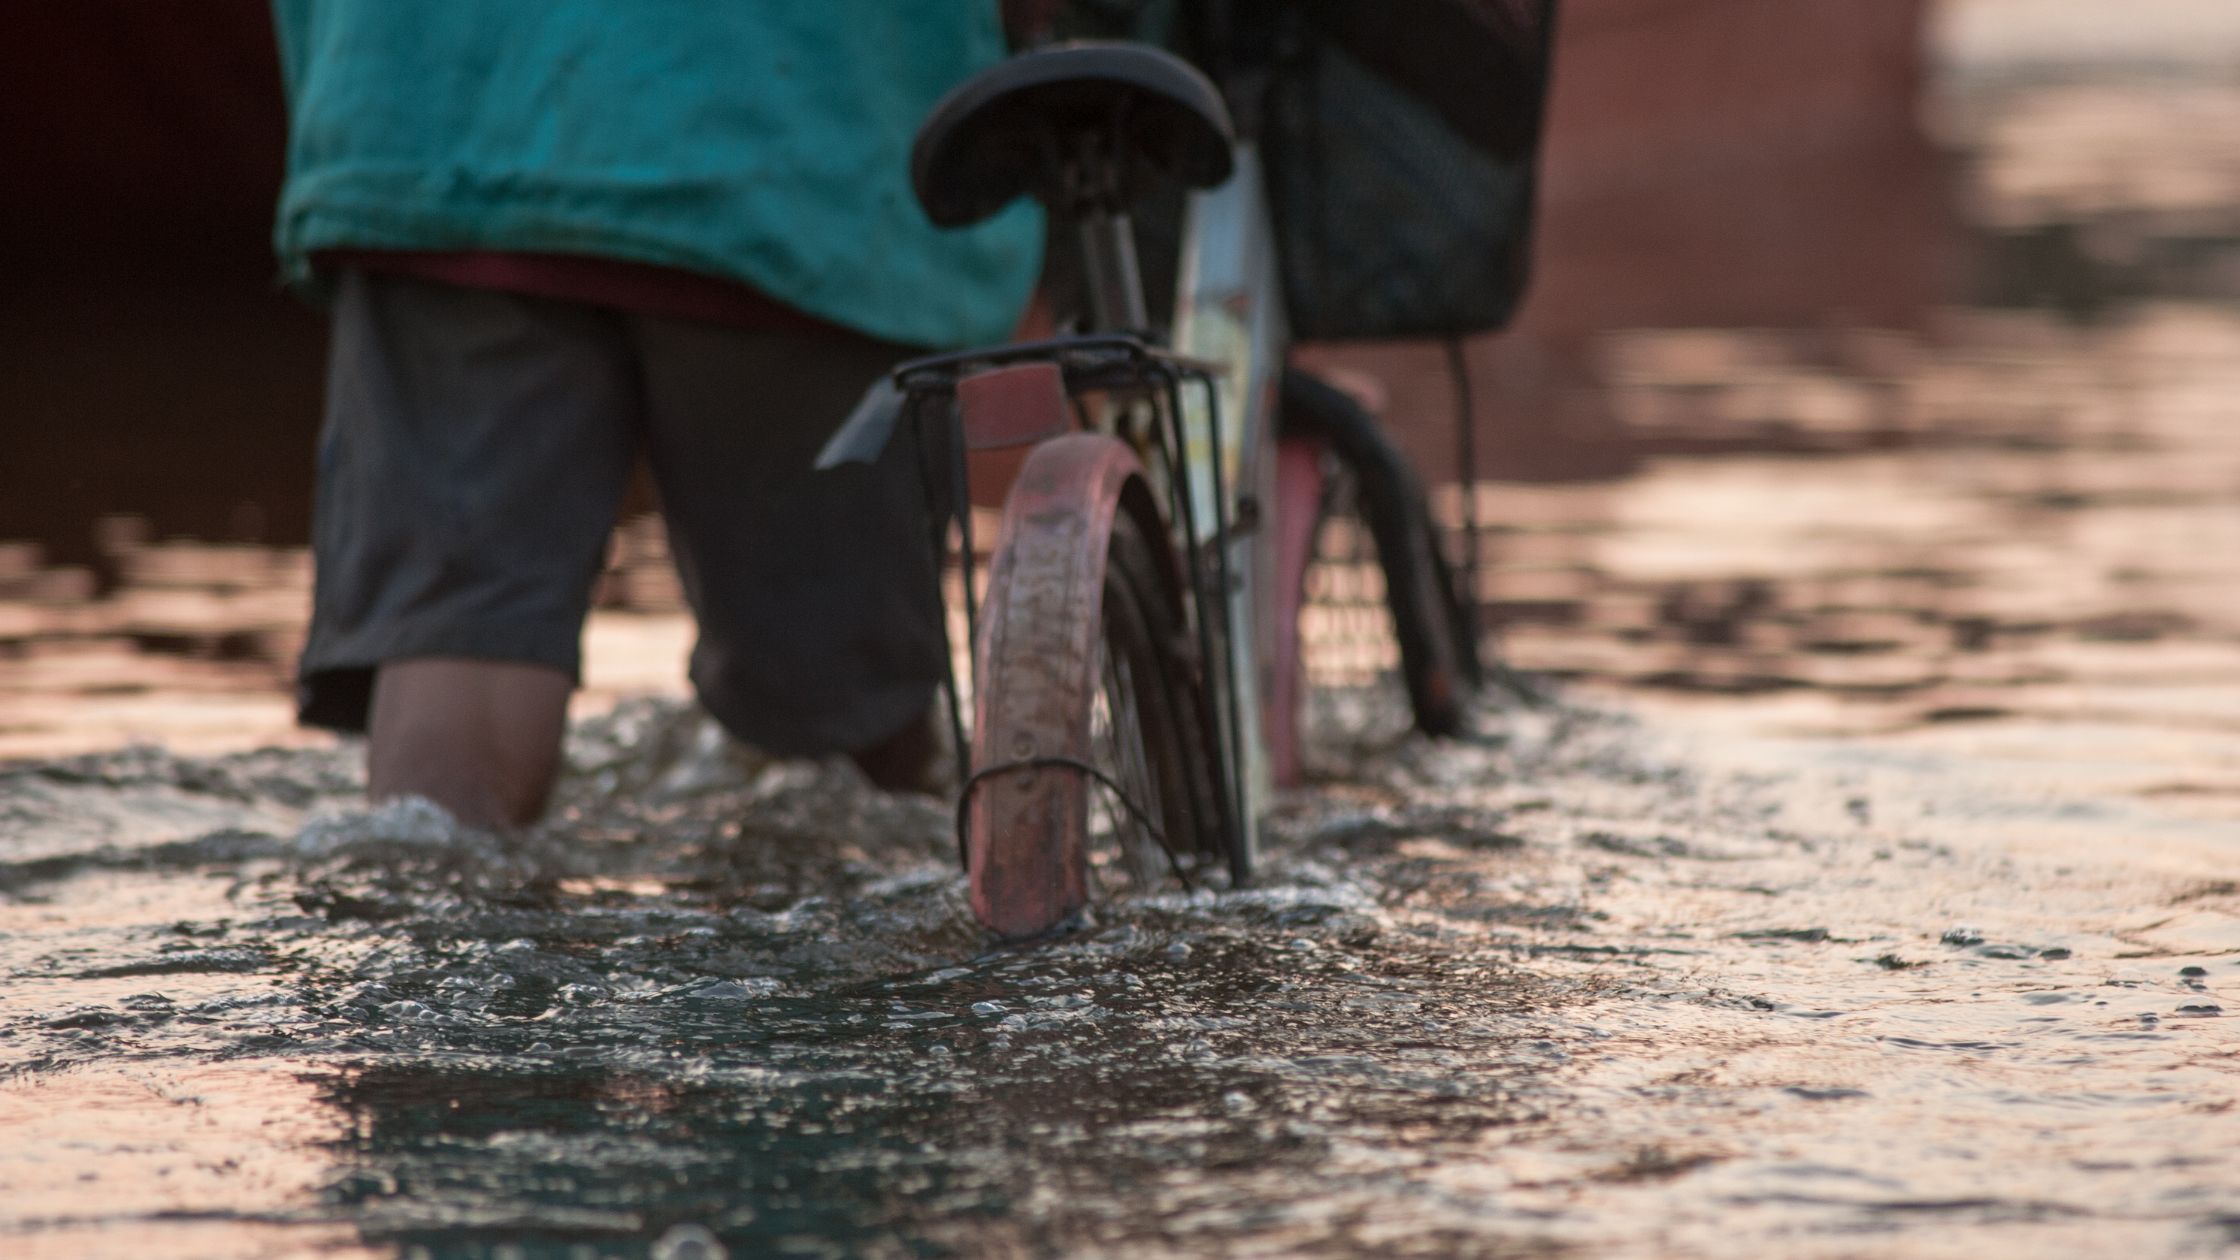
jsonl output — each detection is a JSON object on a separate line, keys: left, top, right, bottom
{"left": 273, "top": 0, "right": 1042, "bottom": 827}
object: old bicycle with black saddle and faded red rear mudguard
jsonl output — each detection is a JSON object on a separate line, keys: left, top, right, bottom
{"left": 820, "top": 43, "right": 1481, "bottom": 939}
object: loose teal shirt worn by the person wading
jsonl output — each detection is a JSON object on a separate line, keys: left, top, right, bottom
{"left": 273, "top": 0, "right": 1042, "bottom": 348}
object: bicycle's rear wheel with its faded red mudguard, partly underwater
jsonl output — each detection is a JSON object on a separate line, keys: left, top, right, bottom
{"left": 965, "top": 435, "right": 1250, "bottom": 939}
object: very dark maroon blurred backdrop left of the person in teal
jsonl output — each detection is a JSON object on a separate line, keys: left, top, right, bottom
{"left": 0, "top": 0, "right": 325, "bottom": 560}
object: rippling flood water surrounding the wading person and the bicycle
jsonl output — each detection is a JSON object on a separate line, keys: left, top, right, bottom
{"left": 0, "top": 9, "right": 2240, "bottom": 1260}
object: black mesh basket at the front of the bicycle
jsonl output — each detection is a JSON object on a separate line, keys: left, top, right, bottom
{"left": 1261, "top": 0, "right": 1557, "bottom": 341}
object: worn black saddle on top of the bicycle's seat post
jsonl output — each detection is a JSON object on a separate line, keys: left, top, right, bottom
{"left": 909, "top": 43, "right": 1232, "bottom": 226}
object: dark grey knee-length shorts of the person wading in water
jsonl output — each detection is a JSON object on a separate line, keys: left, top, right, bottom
{"left": 298, "top": 271, "right": 941, "bottom": 753}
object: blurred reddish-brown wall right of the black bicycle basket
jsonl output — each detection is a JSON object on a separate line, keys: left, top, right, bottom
{"left": 1319, "top": 0, "right": 1962, "bottom": 478}
